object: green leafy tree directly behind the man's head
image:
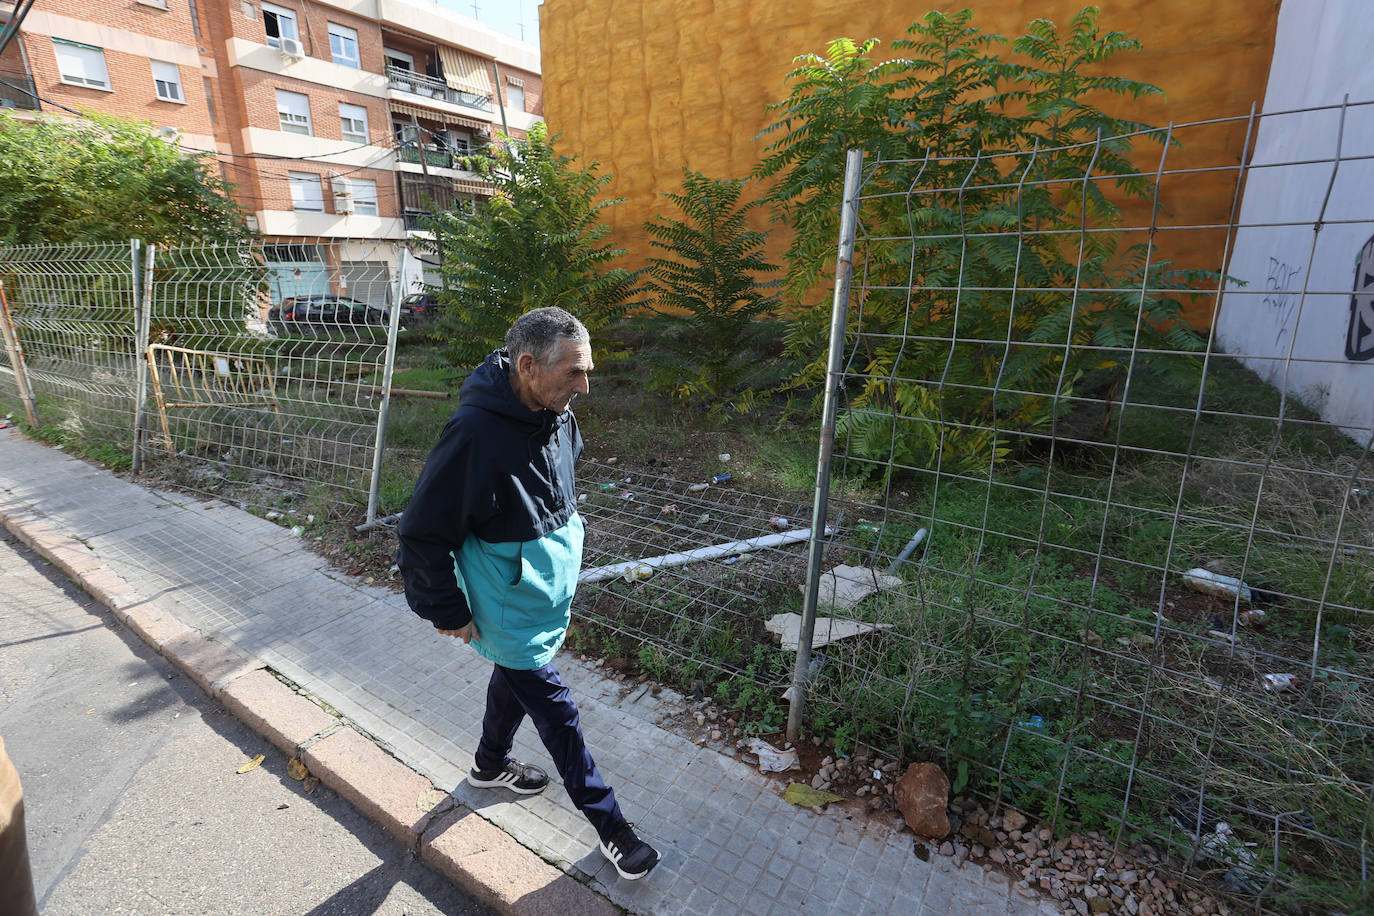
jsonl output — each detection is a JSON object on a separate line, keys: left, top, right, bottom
{"left": 426, "top": 124, "right": 639, "bottom": 368}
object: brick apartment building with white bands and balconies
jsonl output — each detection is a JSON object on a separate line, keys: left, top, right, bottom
{"left": 0, "top": 0, "right": 543, "bottom": 305}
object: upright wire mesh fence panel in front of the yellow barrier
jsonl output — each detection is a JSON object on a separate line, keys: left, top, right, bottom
{"left": 143, "top": 240, "right": 400, "bottom": 503}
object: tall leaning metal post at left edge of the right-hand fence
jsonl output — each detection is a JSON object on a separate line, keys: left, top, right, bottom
{"left": 787, "top": 150, "right": 863, "bottom": 743}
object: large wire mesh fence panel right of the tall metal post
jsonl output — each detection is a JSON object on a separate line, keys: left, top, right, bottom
{"left": 802, "top": 106, "right": 1374, "bottom": 909}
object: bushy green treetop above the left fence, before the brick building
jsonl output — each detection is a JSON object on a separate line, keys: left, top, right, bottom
{"left": 0, "top": 114, "right": 253, "bottom": 244}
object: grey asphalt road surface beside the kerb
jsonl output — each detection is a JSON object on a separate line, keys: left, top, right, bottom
{"left": 0, "top": 530, "right": 489, "bottom": 916}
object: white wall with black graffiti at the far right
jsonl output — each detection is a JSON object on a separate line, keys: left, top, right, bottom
{"left": 1216, "top": 0, "right": 1374, "bottom": 444}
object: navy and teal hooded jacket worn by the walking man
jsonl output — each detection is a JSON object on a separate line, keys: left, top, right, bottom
{"left": 396, "top": 350, "right": 583, "bottom": 670}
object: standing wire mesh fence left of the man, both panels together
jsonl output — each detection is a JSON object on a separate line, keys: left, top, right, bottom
{"left": 0, "top": 239, "right": 406, "bottom": 516}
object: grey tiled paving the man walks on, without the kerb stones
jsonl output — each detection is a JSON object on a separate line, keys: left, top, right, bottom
{"left": 0, "top": 430, "right": 1058, "bottom": 916}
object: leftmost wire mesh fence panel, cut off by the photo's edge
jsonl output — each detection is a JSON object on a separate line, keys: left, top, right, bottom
{"left": 0, "top": 244, "right": 137, "bottom": 444}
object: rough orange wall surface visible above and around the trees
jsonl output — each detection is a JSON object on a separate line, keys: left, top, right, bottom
{"left": 540, "top": 0, "right": 1279, "bottom": 323}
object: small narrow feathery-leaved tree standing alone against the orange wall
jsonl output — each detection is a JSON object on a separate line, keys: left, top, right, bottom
{"left": 644, "top": 169, "right": 778, "bottom": 402}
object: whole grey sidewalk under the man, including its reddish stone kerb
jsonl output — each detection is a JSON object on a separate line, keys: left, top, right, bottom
{"left": 0, "top": 428, "right": 1059, "bottom": 916}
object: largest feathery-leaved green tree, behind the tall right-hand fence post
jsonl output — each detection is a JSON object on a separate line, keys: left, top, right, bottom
{"left": 756, "top": 7, "right": 1216, "bottom": 472}
